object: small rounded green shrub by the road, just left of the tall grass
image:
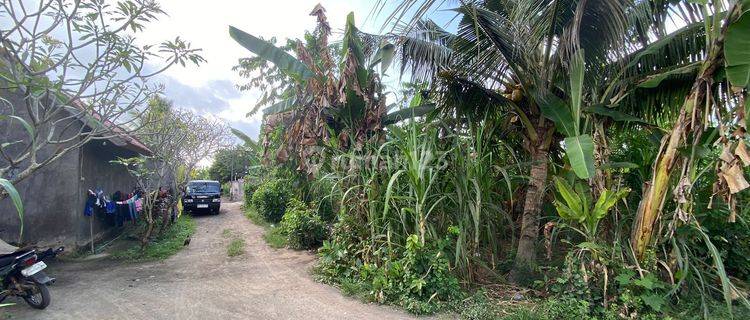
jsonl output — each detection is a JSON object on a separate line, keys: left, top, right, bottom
{"left": 281, "top": 199, "right": 326, "bottom": 249}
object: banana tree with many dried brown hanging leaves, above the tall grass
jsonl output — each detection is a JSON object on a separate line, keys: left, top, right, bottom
{"left": 229, "top": 5, "right": 430, "bottom": 173}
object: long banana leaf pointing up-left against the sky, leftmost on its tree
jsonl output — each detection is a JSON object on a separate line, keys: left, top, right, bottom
{"left": 229, "top": 26, "right": 315, "bottom": 80}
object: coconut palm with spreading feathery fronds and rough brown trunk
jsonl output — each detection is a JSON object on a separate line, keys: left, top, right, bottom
{"left": 382, "top": 0, "right": 632, "bottom": 280}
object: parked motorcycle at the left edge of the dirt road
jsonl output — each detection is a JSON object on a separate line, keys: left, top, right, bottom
{"left": 0, "top": 247, "right": 65, "bottom": 309}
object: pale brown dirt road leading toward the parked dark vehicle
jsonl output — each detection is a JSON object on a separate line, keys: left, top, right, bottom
{"left": 5, "top": 203, "right": 418, "bottom": 320}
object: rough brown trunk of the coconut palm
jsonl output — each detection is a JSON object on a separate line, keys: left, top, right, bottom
{"left": 509, "top": 129, "right": 553, "bottom": 283}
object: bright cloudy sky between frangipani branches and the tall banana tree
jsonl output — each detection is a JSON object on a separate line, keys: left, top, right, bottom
{"left": 138, "top": 0, "right": 412, "bottom": 138}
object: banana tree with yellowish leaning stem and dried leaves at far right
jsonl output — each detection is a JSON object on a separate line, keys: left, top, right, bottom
{"left": 584, "top": 1, "right": 750, "bottom": 258}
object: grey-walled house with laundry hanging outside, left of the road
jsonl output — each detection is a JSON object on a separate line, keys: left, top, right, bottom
{"left": 0, "top": 92, "right": 151, "bottom": 246}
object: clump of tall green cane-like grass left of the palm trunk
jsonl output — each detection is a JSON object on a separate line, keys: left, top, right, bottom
{"left": 320, "top": 122, "right": 522, "bottom": 282}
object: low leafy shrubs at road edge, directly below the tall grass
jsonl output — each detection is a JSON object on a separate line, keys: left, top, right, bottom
{"left": 316, "top": 215, "right": 463, "bottom": 314}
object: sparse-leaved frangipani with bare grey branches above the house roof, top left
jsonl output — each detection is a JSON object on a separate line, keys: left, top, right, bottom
{"left": 0, "top": 0, "right": 204, "bottom": 199}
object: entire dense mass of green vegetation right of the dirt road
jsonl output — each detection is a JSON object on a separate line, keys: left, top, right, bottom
{"left": 229, "top": 0, "right": 750, "bottom": 319}
